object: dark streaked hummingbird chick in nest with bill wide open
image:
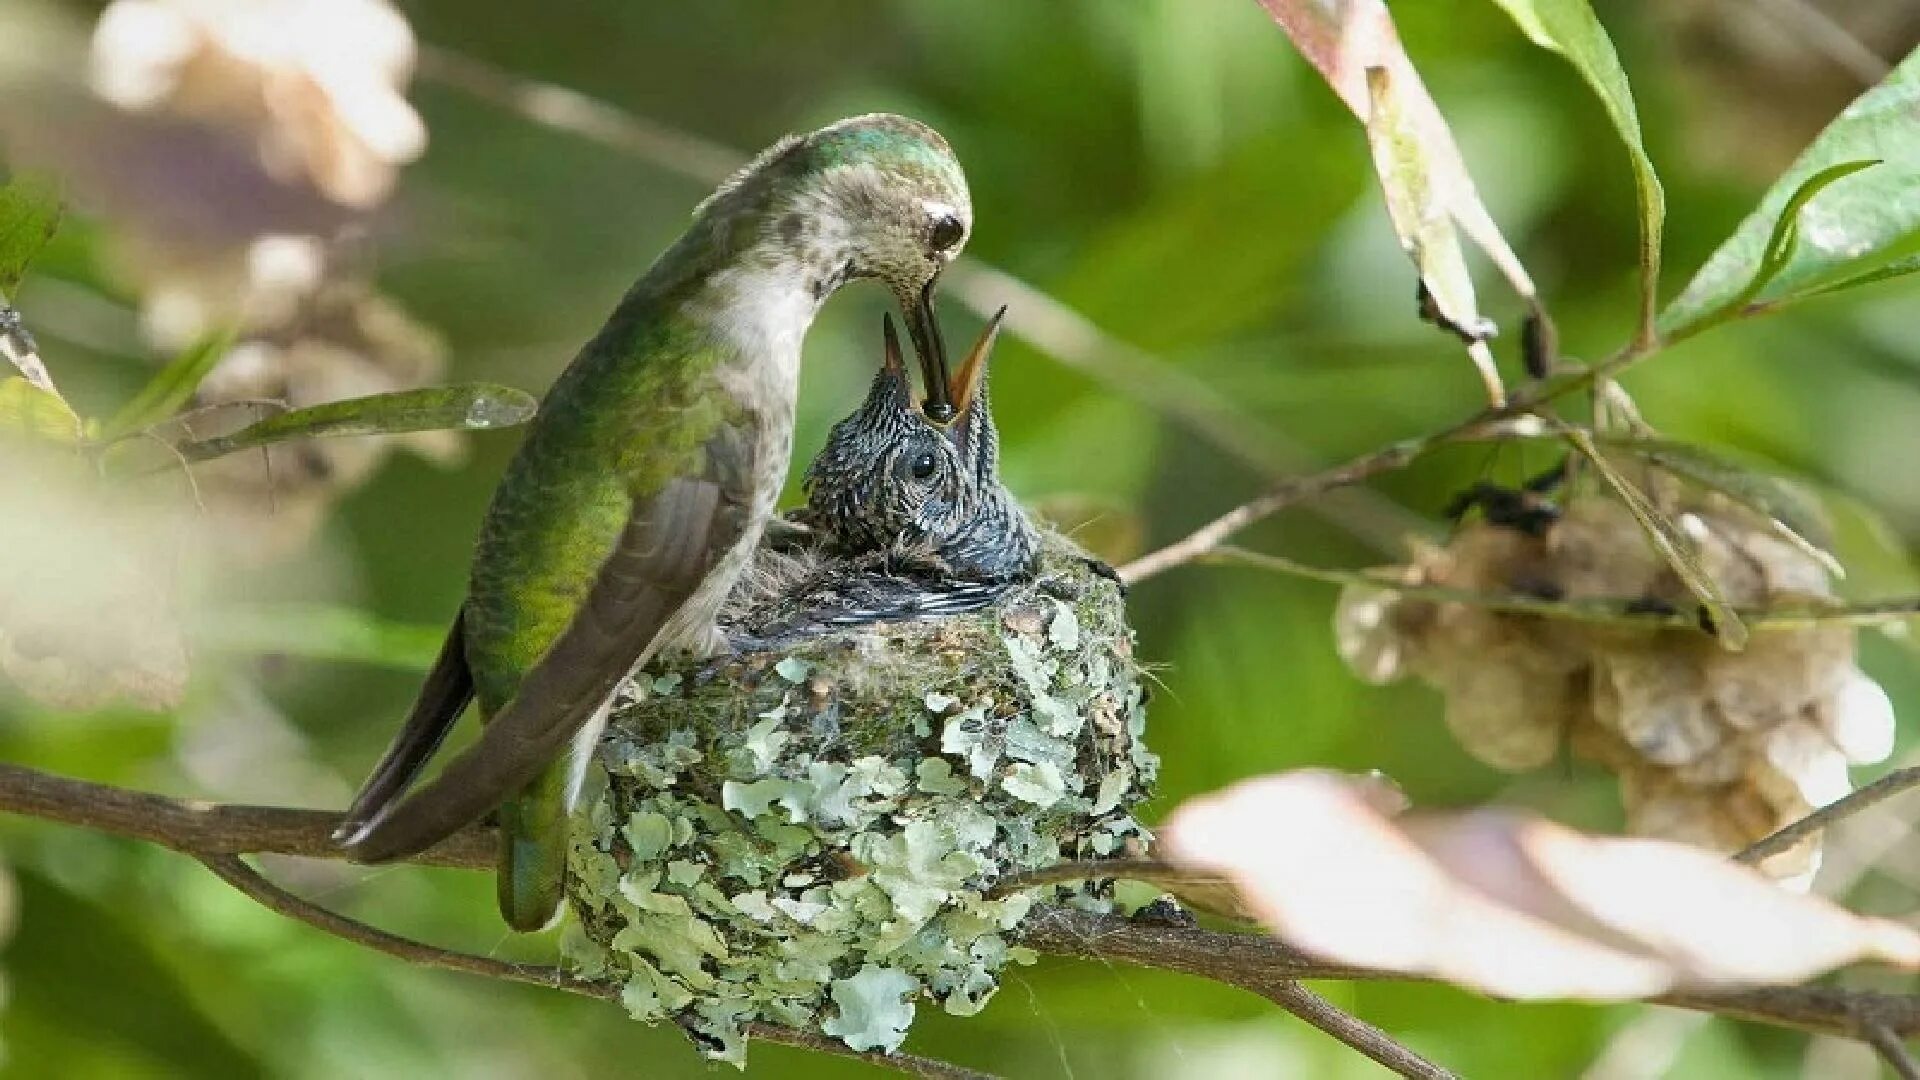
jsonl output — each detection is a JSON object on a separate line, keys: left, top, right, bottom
{"left": 722, "top": 309, "right": 1039, "bottom": 648}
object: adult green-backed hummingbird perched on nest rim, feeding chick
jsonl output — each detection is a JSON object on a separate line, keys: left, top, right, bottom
{"left": 336, "top": 113, "right": 972, "bottom": 930}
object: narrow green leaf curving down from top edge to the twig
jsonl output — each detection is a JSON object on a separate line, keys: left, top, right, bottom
{"left": 1494, "top": 0, "right": 1667, "bottom": 338}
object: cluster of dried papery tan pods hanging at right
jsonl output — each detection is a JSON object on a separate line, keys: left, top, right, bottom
{"left": 1336, "top": 494, "right": 1893, "bottom": 886}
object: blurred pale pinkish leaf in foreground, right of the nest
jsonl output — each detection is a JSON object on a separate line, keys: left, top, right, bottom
{"left": 1160, "top": 773, "right": 1920, "bottom": 999}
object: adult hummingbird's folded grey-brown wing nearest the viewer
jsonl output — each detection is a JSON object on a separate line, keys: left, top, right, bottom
{"left": 344, "top": 427, "right": 755, "bottom": 863}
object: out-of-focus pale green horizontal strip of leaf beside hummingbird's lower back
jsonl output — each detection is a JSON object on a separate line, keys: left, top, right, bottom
{"left": 194, "top": 603, "right": 447, "bottom": 671}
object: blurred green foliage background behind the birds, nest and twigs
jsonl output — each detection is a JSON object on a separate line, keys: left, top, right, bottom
{"left": 0, "top": 0, "right": 1920, "bottom": 1080}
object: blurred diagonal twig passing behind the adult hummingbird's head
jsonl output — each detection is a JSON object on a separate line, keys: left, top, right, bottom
{"left": 408, "top": 46, "right": 1421, "bottom": 552}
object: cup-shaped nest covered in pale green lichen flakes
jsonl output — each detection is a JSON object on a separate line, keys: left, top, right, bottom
{"left": 566, "top": 536, "right": 1156, "bottom": 1063}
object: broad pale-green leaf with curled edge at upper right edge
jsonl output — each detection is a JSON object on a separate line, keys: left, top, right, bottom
{"left": 1659, "top": 50, "right": 1920, "bottom": 338}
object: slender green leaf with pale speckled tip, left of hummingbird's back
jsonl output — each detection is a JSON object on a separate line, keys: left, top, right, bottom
{"left": 180, "top": 382, "right": 538, "bottom": 461}
